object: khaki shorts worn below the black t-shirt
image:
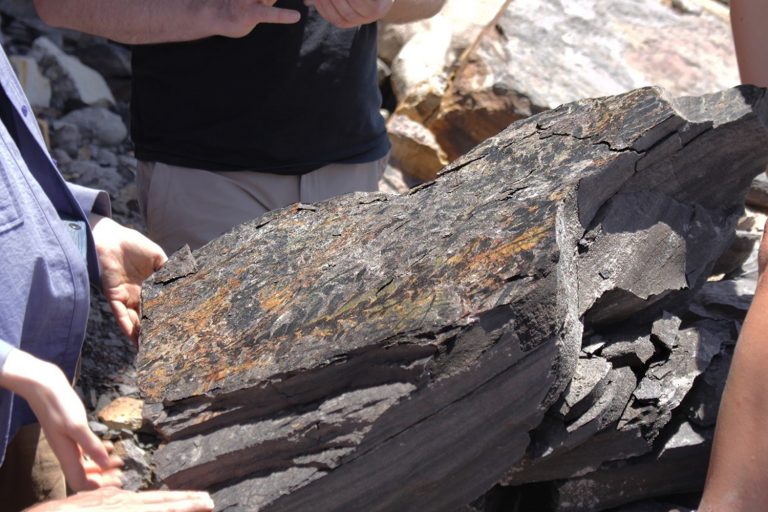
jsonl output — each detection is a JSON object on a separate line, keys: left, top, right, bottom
{"left": 136, "top": 156, "right": 389, "bottom": 254}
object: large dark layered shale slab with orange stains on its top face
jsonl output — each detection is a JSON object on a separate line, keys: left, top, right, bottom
{"left": 138, "top": 88, "right": 768, "bottom": 511}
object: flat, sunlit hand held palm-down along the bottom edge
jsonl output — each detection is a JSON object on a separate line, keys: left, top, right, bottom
{"left": 25, "top": 488, "right": 213, "bottom": 512}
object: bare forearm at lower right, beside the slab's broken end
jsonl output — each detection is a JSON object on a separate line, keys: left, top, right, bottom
{"left": 699, "top": 275, "right": 768, "bottom": 512}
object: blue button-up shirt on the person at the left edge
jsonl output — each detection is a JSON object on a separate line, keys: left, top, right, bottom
{"left": 0, "top": 46, "right": 110, "bottom": 464}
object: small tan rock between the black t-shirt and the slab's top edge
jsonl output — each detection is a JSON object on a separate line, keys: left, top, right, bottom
{"left": 387, "top": 114, "right": 448, "bottom": 181}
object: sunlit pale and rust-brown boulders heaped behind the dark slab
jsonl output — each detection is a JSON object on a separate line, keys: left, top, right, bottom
{"left": 382, "top": 0, "right": 739, "bottom": 180}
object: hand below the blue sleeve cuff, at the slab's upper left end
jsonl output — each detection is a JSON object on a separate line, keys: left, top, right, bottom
{"left": 90, "top": 215, "right": 168, "bottom": 345}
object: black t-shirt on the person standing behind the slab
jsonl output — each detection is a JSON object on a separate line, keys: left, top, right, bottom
{"left": 131, "top": 0, "right": 389, "bottom": 174}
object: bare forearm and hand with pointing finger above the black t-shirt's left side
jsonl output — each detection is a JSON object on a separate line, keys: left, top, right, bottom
{"left": 34, "top": 0, "right": 299, "bottom": 44}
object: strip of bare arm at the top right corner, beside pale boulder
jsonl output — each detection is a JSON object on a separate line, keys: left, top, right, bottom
{"left": 731, "top": 0, "right": 768, "bottom": 87}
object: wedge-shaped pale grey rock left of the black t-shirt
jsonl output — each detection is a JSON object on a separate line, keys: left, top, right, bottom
{"left": 32, "top": 37, "right": 115, "bottom": 108}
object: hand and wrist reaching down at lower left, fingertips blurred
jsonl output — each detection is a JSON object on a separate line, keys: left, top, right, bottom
{"left": 0, "top": 349, "right": 123, "bottom": 491}
